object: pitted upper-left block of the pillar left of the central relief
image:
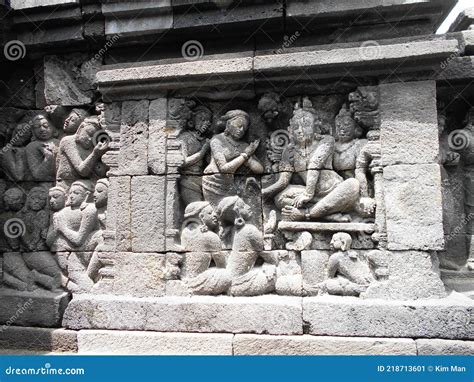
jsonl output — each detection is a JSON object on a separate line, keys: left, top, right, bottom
{"left": 119, "top": 100, "right": 149, "bottom": 175}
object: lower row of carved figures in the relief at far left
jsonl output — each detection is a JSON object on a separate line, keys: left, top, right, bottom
{"left": 0, "top": 179, "right": 109, "bottom": 291}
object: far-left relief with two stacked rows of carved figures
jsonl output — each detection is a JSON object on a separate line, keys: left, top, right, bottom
{"left": 0, "top": 107, "right": 108, "bottom": 292}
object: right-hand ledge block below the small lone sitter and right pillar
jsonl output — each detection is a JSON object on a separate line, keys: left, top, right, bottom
{"left": 303, "top": 292, "right": 474, "bottom": 340}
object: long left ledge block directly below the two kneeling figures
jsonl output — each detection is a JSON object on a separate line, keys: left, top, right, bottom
{"left": 63, "top": 295, "right": 303, "bottom": 334}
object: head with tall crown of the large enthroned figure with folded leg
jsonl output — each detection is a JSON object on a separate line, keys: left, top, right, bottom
{"left": 289, "top": 98, "right": 321, "bottom": 146}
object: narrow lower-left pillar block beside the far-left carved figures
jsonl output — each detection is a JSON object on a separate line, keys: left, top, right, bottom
{"left": 107, "top": 176, "right": 132, "bottom": 252}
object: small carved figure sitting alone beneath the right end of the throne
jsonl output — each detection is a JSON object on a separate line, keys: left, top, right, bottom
{"left": 320, "top": 232, "right": 375, "bottom": 296}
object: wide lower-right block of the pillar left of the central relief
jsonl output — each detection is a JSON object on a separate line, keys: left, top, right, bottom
{"left": 132, "top": 176, "right": 166, "bottom": 252}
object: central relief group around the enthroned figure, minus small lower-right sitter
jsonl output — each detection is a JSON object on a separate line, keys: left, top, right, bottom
{"left": 168, "top": 88, "right": 383, "bottom": 296}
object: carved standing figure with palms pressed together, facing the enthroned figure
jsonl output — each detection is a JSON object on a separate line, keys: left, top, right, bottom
{"left": 202, "top": 110, "right": 264, "bottom": 207}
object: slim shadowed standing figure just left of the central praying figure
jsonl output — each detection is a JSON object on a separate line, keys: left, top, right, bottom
{"left": 178, "top": 106, "right": 212, "bottom": 205}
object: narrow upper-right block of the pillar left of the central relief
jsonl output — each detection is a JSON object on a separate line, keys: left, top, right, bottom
{"left": 148, "top": 98, "right": 168, "bottom": 175}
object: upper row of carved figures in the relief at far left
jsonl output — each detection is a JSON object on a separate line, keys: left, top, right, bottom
{"left": 0, "top": 109, "right": 109, "bottom": 186}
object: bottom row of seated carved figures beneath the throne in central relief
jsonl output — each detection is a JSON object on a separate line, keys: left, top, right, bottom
{"left": 176, "top": 196, "right": 388, "bottom": 296}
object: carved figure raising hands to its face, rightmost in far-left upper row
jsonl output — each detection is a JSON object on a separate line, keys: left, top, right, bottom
{"left": 57, "top": 117, "right": 108, "bottom": 183}
